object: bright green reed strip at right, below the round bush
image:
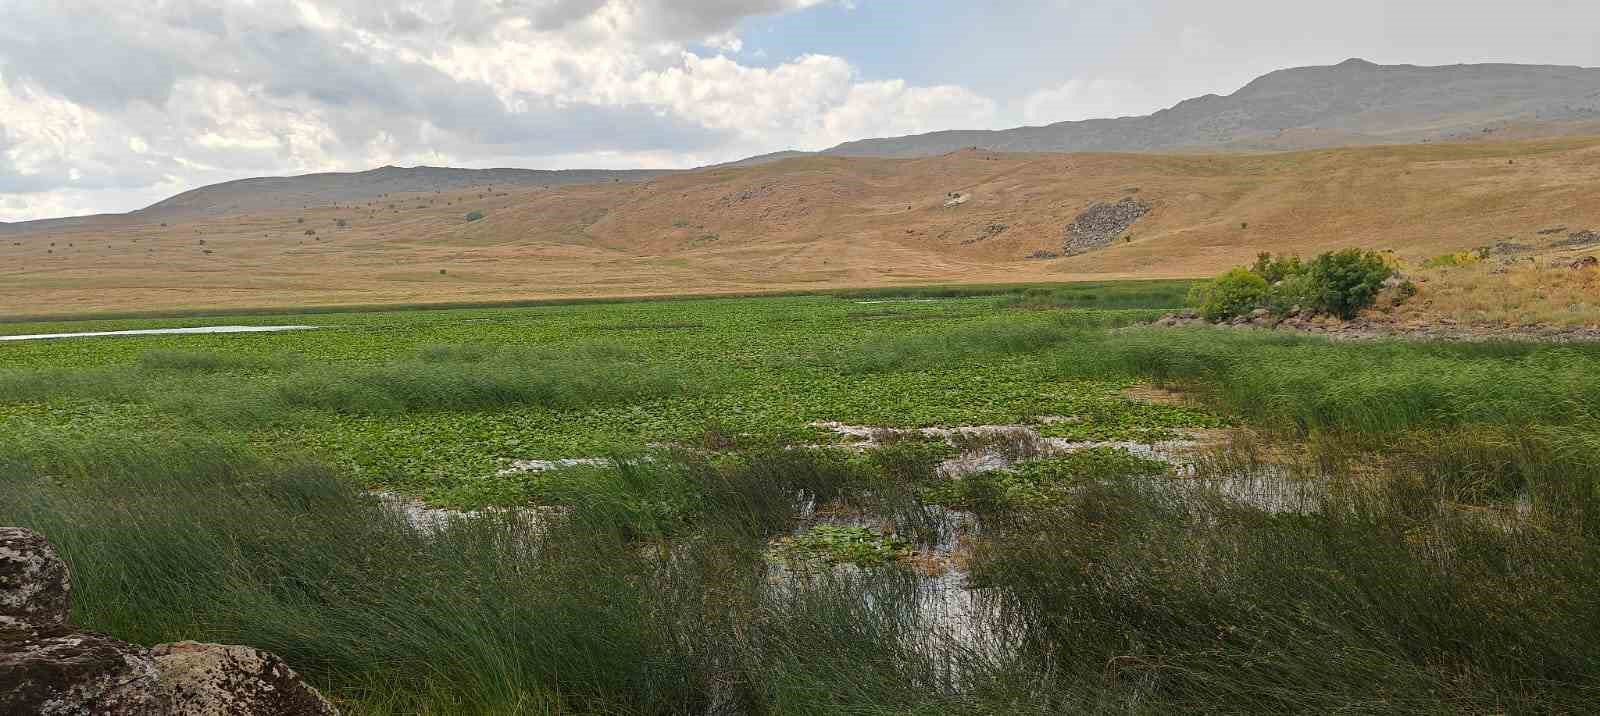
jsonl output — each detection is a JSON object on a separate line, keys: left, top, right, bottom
{"left": 1064, "top": 329, "right": 1600, "bottom": 433}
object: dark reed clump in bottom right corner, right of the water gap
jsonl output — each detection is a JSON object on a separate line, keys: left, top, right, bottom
{"left": 974, "top": 463, "right": 1600, "bottom": 713}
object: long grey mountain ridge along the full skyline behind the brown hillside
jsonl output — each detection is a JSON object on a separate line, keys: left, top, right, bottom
{"left": 0, "top": 58, "right": 1600, "bottom": 235}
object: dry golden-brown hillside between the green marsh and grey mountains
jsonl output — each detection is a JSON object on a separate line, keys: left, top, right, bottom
{"left": 0, "top": 137, "right": 1600, "bottom": 315}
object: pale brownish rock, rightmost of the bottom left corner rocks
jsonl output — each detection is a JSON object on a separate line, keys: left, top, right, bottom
{"left": 150, "top": 641, "right": 339, "bottom": 716}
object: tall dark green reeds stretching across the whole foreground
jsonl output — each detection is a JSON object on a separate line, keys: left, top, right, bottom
{"left": 0, "top": 418, "right": 1600, "bottom": 714}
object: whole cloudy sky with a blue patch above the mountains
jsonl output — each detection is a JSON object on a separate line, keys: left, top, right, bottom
{"left": 0, "top": 0, "right": 1600, "bottom": 221}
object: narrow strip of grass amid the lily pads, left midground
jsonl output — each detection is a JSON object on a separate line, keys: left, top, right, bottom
{"left": 0, "top": 342, "right": 714, "bottom": 427}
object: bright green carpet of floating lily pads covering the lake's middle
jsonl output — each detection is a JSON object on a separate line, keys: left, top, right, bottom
{"left": 0, "top": 288, "right": 1205, "bottom": 503}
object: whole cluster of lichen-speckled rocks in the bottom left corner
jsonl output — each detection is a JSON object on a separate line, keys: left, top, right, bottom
{"left": 0, "top": 527, "right": 339, "bottom": 716}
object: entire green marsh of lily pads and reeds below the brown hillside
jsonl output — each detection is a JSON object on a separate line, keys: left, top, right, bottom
{"left": 0, "top": 286, "right": 1600, "bottom": 714}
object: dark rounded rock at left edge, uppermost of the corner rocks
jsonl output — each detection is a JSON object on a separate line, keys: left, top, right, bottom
{"left": 0, "top": 527, "right": 72, "bottom": 639}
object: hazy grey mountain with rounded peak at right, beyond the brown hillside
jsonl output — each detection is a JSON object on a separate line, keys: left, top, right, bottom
{"left": 824, "top": 58, "right": 1600, "bottom": 157}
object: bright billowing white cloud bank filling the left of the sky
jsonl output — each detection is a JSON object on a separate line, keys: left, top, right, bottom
{"left": 0, "top": 0, "right": 997, "bottom": 221}
